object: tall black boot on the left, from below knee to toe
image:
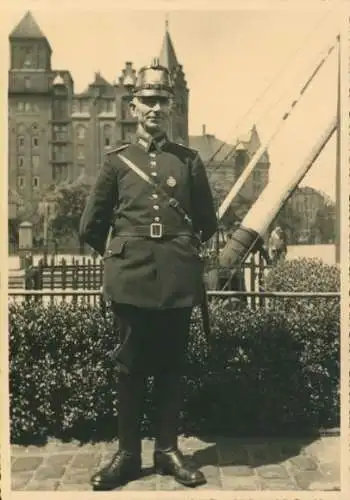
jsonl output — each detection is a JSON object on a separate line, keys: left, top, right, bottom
{"left": 91, "top": 373, "right": 146, "bottom": 490}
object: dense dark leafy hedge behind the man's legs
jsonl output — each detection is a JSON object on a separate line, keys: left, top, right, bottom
{"left": 9, "top": 256, "right": 340, "bottom": 443}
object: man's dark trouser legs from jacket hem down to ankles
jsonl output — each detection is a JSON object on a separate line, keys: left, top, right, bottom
{"left": 112, "top": 303, "right": 192, "bottom": 454}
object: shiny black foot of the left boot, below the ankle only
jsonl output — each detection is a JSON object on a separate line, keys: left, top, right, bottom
{"left": 91, "top": 451, "right": 141, "bottom": 491}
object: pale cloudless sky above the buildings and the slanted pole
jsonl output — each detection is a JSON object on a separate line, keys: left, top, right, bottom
{"left": 1, "top": 0, "right": 339, "bottom": 199}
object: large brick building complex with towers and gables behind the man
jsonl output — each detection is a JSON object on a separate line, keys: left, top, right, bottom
{"left": 8, "top": 12, "right": 269, "bottom": 240}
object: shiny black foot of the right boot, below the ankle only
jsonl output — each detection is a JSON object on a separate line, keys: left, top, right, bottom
{"left": 154, "top": 449, "right": 207, "bottom": 488}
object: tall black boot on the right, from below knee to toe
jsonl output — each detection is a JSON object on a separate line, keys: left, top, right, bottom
{"left": 154, "top": 373, "right": 206, "bottom": 487}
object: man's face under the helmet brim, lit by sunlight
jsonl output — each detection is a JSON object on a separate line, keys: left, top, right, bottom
{"left": 130, "top": 96, "right": 171, "bottom": 134}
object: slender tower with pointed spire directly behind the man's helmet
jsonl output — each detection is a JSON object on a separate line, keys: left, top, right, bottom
{"left": 159, "top": 20, "right": 189, "bottom": 146}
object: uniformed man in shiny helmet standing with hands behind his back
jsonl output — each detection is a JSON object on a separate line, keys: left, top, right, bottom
{"left": 80, "top": 57, "right": 217, "bottom": 490}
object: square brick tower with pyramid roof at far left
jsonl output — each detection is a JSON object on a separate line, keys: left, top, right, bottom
{"left": 8, "top": 12, "right": 73, "bottom": 216}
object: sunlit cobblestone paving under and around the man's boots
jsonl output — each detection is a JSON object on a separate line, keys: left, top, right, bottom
{"left": 11, "top": 436, "right": 340, "bottom": 491}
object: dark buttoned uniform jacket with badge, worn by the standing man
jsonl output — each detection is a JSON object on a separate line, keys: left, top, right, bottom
{"left": 80, "top": 132, "right": 217, "bottom": 309}
